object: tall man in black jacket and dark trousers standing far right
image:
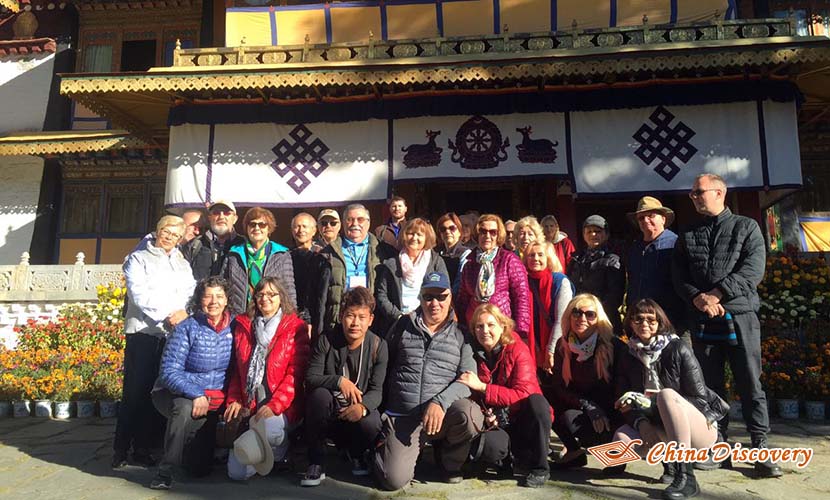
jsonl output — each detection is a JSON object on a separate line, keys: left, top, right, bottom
{"left": 672, "top": 174, "right": 783, "bottom": 477}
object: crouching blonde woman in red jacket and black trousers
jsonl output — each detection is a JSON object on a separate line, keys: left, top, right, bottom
{"left": 459, "top": 304, "right": 553, "bottom": 488}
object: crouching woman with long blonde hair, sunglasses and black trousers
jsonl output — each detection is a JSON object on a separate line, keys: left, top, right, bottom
{"left": 551, "top": 293, "right": 616, "bottom": 469}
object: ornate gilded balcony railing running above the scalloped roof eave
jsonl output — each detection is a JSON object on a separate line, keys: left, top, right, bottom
{"left": 173, "top": 16, "right": 795, "bottom": 67}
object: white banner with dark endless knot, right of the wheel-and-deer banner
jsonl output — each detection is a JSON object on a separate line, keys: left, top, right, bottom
{"left": 571, "top": 101, "right": 801, "bottom": 194}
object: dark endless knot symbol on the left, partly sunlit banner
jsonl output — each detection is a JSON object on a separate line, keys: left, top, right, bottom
{"left": 271, "top": 124, "right": 329, "bottom": 194}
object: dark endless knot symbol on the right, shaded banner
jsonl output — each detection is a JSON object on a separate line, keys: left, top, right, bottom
{"left": 632, "top": 106, "right": 697, "bottom": 181}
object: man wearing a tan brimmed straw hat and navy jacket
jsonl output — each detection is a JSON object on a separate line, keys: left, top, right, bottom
{"left": 626, "top": 196, "right": 689, "bottom": 340}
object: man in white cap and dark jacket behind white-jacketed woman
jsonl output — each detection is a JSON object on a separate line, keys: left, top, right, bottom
{"left": 182, "top": 199, "right": 244, "bottom": 281}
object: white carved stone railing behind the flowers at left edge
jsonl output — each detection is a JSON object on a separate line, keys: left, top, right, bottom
{"left": 0, "top": 252, "right": 124, "bottom": 348}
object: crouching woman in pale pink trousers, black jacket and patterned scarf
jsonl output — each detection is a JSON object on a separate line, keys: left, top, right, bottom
{"left": 614, "top": 299, "right": 728, "bottom": 499}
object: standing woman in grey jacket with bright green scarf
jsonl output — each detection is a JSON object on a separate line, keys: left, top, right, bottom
{"left": 221, "top": 207, "right": 297, "bottom": 315}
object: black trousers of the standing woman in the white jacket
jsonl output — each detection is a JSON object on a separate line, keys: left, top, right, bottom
{"left": 113, "top": 333, "right": 164, "bottom": 454}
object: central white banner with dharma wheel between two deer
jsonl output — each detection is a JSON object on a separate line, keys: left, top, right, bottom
{"left": 392, "top": 113, "right": 568, "bottom": 180}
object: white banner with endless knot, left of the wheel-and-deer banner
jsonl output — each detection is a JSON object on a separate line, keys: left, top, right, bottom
{"left": 165, "top": 120, "right": 389, "bottom": 206}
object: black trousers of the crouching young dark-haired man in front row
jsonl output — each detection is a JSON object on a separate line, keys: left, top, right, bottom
{"left": 304, "top": 387, "right": 381, "bottom": 465}
